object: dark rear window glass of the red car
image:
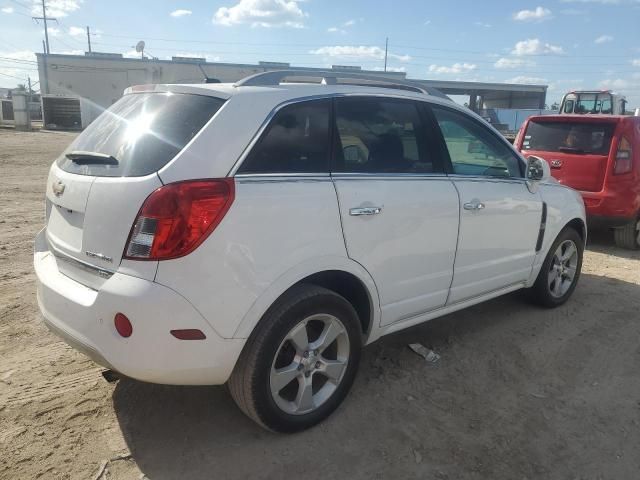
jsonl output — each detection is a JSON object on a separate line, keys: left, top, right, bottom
{"left": 522, "top": 121, "right": 615, "bottom": 155}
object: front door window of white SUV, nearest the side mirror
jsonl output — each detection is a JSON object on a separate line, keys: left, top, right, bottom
{"left": 432, "top": 106, "right": 522, "bottom": 178}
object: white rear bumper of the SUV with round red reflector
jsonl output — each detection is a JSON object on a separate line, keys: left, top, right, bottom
{"left": 34, "top": 230, "right": 245, "bottom": 385}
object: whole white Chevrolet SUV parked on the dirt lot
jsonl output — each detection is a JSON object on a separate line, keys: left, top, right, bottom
{"left": 34, "top": 72, "right": 586, "bottom": 432}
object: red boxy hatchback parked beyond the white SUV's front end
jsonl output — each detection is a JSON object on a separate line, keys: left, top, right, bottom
{"left": 514, "top": 115, "right": 640, "bottom": 249}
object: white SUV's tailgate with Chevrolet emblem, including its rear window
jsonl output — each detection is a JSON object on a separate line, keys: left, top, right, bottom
{"left": 46, "top": 93, "right": 222, "bottom": 288}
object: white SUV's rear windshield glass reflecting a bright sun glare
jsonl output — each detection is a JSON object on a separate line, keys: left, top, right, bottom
{"left": 58, "top": 93, "right": 224, "bottom": 177}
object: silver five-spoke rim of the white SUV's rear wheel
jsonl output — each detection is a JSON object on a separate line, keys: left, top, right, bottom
{"left": 269, "top": 314, "right": 350, "bottom": 415}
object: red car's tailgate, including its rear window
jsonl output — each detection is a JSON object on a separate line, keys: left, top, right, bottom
{"left": 520, "top": 117, "right": 617, "bottom": 192}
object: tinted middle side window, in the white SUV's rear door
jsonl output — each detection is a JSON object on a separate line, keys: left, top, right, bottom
{"left": 334, "top": 97, "right": 434, "bottom": 173}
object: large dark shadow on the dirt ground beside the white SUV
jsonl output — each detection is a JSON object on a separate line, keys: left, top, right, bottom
{"left": 113, "top": 275, "right": 640, "bottom": 480}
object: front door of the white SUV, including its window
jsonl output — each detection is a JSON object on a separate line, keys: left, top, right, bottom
{"left": 432, "top": 105, "right": 542, "bottom": 304}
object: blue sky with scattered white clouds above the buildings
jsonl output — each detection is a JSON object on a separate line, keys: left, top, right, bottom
{"left": 0, "top": 0, "right": 640, "bottom": 107}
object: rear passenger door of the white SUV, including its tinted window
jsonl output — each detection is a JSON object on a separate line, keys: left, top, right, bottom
{"left": 332, "top": 97, "right": 458, "bottom": 325}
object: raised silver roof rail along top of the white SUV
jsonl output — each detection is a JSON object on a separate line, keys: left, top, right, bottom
{"left": 234, "top": 70, "right": 449, "bottom": 99}
